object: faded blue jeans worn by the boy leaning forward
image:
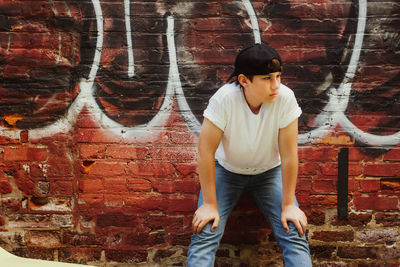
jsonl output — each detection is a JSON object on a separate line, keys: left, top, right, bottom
{"left": 187, "top": 162, "right": 312, "bottom": 267}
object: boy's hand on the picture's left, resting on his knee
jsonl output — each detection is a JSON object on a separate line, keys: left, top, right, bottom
{"left": 192, "top": 203, "right": 219, "bottom": 234}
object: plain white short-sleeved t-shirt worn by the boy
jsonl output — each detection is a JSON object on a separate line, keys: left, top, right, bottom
{"left": 204, "top": 83, "right": 301, "bottom": 174}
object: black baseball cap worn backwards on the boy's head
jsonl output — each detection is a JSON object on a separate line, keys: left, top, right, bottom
{"left": 226, "top": 44, "right": 282, "bottom": 82}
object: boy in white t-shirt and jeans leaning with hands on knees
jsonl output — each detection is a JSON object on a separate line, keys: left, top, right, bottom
{"left": 187, "top": 44, "right": 311, "bottom": 267}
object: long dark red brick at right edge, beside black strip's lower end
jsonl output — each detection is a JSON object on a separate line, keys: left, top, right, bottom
{"left": 354, "top": 196, "right": 399, "bottom": 210}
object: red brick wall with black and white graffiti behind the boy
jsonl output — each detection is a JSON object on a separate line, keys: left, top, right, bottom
{"left": 0, "top": 0, "right": 400, "bottom": 266}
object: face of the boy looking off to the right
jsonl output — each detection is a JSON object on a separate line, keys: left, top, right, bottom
{"left": 246, "top": 72, "right": 281, "bottom": 103}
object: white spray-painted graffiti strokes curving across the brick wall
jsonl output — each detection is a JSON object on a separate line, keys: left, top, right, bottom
{"left": 0, "top": 0, "right": 400, "bottom": 146}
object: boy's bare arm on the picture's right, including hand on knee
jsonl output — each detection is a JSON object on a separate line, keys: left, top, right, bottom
{"left": 278, "top": 119, "right": 307, "bottom": 235}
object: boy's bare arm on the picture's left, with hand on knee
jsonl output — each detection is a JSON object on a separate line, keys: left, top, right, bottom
{"left": 192, "top": 118, "right": 223, "bottom": 234}
